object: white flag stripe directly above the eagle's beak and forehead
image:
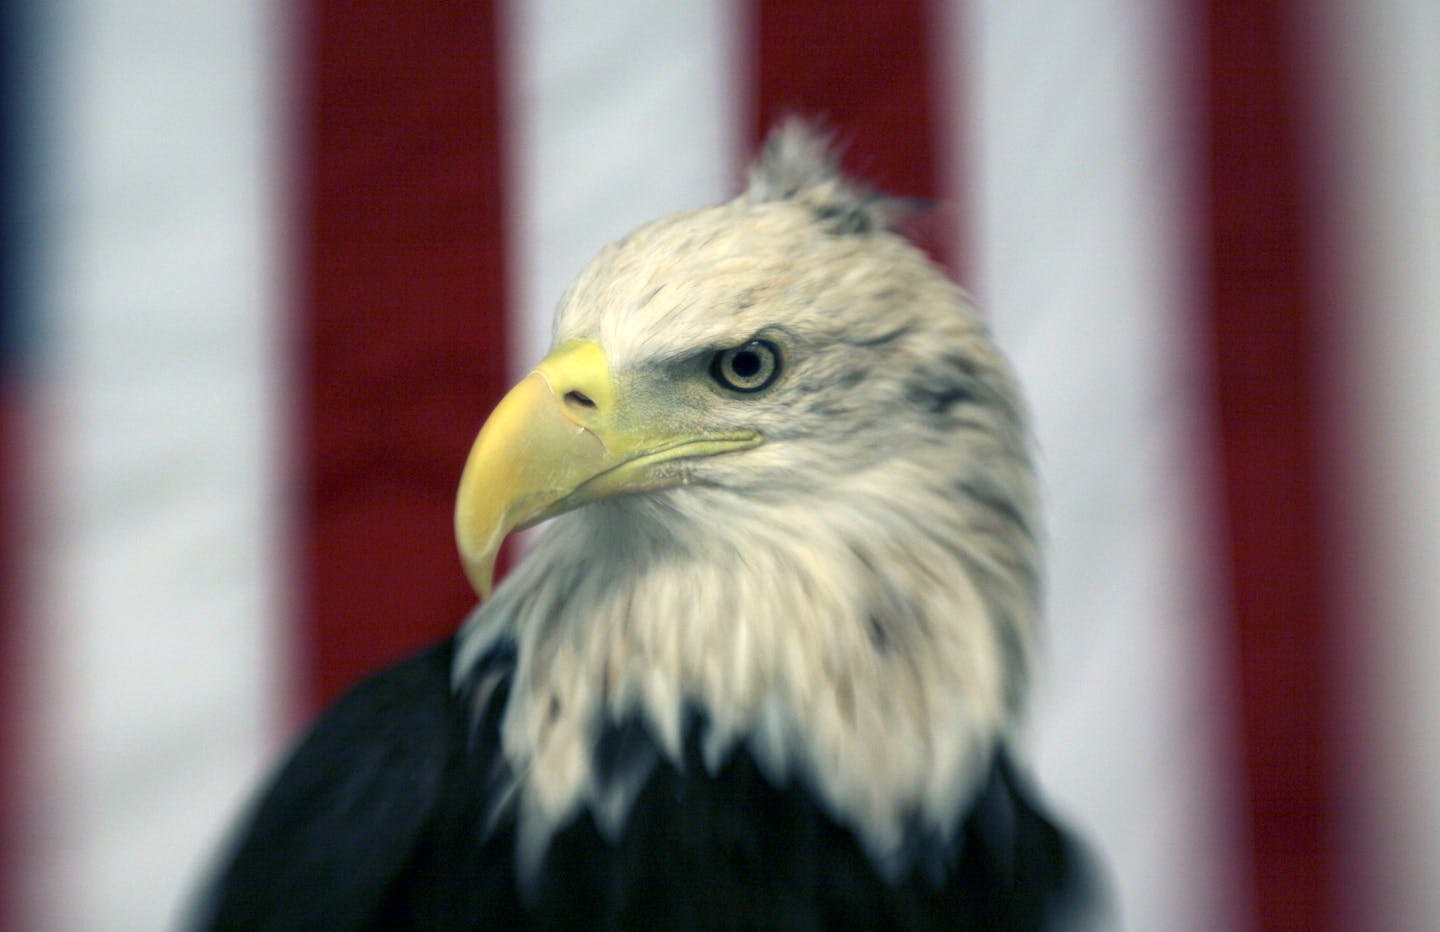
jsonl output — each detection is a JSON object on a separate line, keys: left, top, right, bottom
{"left": 505, "top": 0, "right": 739, "bottom": 375}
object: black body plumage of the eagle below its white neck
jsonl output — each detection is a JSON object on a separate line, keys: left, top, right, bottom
{"left": 196, "top": 641, "right": 1089, "bottom": 929}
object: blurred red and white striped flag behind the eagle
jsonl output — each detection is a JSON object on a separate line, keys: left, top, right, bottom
{"left": 0, "top": 0, "right": 1440, "bottom": 929}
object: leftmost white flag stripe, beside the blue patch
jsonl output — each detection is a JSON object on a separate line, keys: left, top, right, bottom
{"left": 33, "top": 0, "right": 279, "bottom": 929}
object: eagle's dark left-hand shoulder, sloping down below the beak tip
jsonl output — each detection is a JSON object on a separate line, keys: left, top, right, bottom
{"left": 193, "top": 640, "right": 465, "bottom": 929}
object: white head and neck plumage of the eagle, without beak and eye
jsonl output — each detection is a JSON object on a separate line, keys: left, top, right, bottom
{"left": 456, "top": 124, "right": 1040, "bottom": 870}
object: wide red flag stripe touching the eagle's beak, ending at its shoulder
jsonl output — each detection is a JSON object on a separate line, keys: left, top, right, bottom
{"left": 297, "top": 0, "right": 505, "bottom": 707}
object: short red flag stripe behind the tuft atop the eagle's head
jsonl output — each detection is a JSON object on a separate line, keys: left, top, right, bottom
{"left": 746, "top": 0, "right": 962, "bottom": 268}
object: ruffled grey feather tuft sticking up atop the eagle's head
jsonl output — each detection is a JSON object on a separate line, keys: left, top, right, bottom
{"left": 746, "top": 117, "right": 913, "bottom": 235}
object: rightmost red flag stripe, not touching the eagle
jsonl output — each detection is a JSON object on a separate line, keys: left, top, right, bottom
{"left": 1191, "top": 0, "right": 1344, "bottom": 929}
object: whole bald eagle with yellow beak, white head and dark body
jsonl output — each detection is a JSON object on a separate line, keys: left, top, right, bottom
{"left": 196, "top": 122, "right": 1090, "bottom": 929}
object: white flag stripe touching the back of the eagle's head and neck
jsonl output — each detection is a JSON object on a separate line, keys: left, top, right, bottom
{"left": 950, "top": 0, "right": 1236, "bottom": 929}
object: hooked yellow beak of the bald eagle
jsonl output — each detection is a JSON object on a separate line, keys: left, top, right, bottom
{"left": 455, "top": 340, "right": 760, "bottom": 599}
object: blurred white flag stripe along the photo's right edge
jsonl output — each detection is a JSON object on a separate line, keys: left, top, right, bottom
{"left": 1329, "top": 0, "right": 1440, "bottom": 929}
